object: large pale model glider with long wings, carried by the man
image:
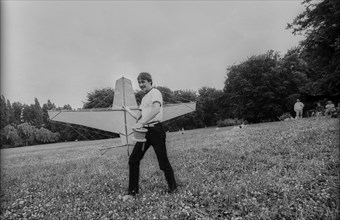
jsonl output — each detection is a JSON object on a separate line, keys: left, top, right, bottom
{"left": 48, "top": 77, "right": 196, "bottom": 153}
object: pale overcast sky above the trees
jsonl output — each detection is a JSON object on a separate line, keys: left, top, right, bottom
{"left": 1, "top": 0, "right": 304, "bottom": 108}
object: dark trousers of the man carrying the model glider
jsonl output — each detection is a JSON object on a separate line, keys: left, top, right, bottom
{"left": 128, "top": 124, "right": 177, "bottom": 194}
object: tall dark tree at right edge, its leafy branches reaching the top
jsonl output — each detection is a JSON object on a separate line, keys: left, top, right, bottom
{"left": 287, "top": 0, "right": 340, "bottom": 99}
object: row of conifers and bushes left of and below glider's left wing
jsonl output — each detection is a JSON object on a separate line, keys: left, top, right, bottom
{"left": 0, "top": 96, "right": 115, "bottom": 148}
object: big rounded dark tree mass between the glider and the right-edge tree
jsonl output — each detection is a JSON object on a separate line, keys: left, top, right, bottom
{"left": 220, "top": 50, "right": 308, "bottom": 122}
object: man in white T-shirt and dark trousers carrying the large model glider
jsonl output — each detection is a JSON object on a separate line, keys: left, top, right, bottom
{"left": 124, "top": 72, "right": 177, "bottom": 196}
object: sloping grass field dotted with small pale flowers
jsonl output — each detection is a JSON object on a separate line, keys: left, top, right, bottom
{"left": 0, "top": 118, "right": 340, "bottom": 220}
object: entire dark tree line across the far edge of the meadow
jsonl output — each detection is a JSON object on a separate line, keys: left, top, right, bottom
{"left": 1, "top": 0, "right": 340, "bottom": 147}
